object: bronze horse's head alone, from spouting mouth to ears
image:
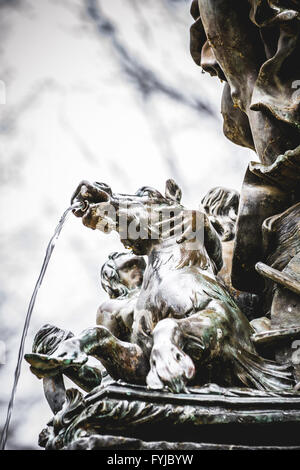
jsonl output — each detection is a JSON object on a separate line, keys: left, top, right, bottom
{"left": 72, "top": 180, "right": 183, "bottom": 255}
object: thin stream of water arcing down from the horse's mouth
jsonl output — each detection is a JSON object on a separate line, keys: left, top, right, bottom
{"left": 0, "top": 202, "right": 82, "bottom": 450}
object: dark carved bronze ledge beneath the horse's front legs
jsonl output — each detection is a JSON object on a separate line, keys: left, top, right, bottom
{"left": 39, "top": 383, "right": 300, "bottom": 450}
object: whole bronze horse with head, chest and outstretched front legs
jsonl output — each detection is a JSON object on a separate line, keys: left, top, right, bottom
{"left": 26, "top": 180, "right": 293, "bottom": 393}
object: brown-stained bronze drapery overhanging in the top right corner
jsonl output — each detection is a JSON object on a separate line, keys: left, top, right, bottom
{"left": 191, "top": 0, "right": 300, "bottom": 165}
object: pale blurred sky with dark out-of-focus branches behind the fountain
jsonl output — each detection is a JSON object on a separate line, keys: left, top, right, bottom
{"left": 0, "top": 0, "right": 255, "bottom": 449}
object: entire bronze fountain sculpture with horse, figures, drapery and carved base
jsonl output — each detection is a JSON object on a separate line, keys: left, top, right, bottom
{"left": 25, "top": 0, "right": 300, "bottom": 449}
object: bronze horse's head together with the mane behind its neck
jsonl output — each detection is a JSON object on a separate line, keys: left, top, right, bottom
{"left": 71, "top": 180, "right": 222, "bottom": 270}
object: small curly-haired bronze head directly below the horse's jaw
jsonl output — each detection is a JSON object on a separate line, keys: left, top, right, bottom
{"left": 101, "top": 252, "right": 146, "bottom": 298}
